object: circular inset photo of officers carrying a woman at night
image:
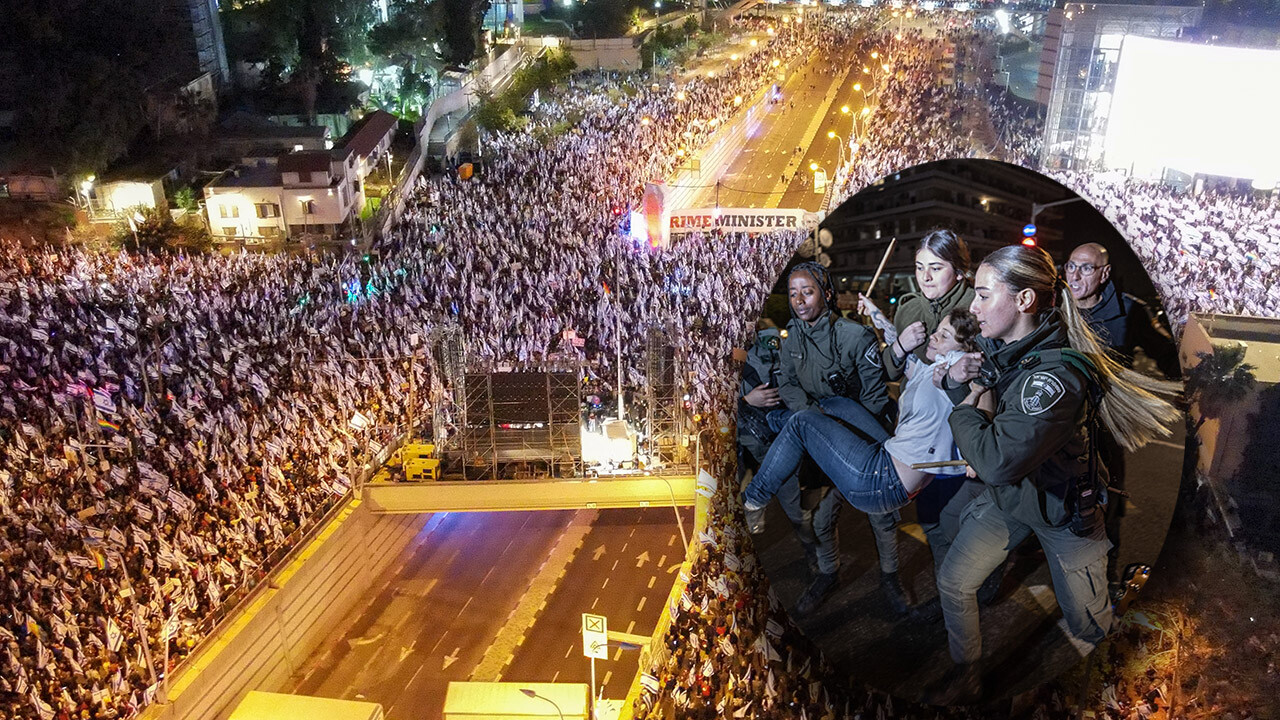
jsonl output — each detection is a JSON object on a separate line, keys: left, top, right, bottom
{"left": 737, "top": 160, "right": 1183, "bottom": 705}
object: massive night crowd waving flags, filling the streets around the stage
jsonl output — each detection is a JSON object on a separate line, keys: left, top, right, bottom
{"left": 0, "top": 5, "right": 1280, "bottom": 720}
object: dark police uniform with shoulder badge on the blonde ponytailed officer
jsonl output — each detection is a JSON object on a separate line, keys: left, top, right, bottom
{"left": 938, "top": 314, "right": 1112, "bottom": 664}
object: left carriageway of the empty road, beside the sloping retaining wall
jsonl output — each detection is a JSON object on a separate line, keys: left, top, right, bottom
{"left": 289, "top": 511, "right": 573, "bottom": 720}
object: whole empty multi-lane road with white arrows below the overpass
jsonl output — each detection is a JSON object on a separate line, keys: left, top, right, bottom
{"left": 288, "top": 507, "right": 692, "bottom": 720}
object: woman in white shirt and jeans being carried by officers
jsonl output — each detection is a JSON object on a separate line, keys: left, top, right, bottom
{"left": 744, "top": 309, "right": 978, "bottom": 525}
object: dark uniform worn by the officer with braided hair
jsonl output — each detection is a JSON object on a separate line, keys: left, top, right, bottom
{"left": 769, "top": 313, "right": 899, "bottom": 574}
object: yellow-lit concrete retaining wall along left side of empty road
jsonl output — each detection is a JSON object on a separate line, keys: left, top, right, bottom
{"left": 143, "top": 500, "right": 430, "bottom": 720}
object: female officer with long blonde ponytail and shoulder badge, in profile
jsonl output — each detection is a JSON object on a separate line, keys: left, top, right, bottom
{"left": 937, "top": 245, "right": 1174, "bottom": 702}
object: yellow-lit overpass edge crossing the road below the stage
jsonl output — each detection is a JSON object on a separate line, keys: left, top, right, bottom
{"left": 364, "top": 474, "right": 696, "bottom": 515}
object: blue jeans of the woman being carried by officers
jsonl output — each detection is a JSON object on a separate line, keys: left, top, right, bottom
{"left": 745, "top": 402, "right": 910, "bottom": 514}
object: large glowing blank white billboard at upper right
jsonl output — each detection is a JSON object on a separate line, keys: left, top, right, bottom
{"left": 1105, "top": 36, "right": 1280, "bottom": 181}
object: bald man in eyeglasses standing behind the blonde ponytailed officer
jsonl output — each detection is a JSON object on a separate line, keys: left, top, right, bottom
{"left": 1062, "top": 242, "right": 1181, "bottom": 598}
